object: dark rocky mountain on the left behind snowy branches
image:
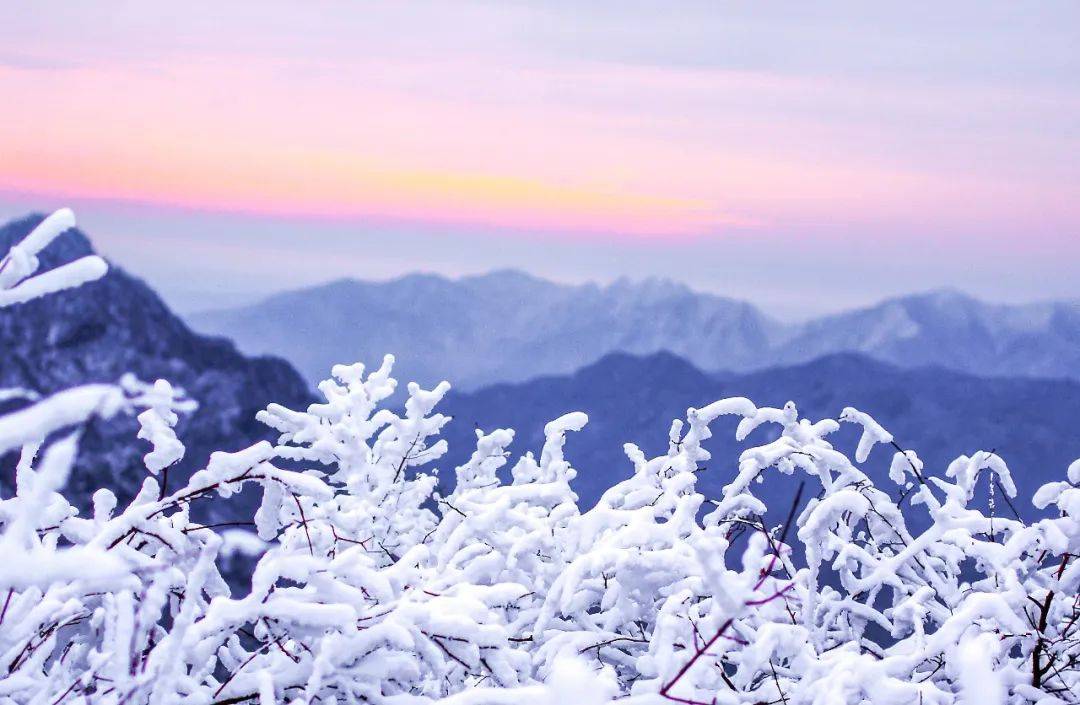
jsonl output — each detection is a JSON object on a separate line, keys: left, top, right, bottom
{"left": 0, "top": 216, "right": 310, "bottom": 516}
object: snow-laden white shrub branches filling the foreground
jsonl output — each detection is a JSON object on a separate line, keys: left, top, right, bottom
{"left": 0, "top": 211, "right": 1080, "bottom": 705}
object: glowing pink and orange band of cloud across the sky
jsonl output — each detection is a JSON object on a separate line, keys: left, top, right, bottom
{"left": 0, "top": 18, "right": 1059, "bottom": 236}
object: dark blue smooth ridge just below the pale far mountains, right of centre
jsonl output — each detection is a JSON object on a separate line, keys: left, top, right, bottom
{"left": 443, "top": 353, "right": 1080, "bottom": 512}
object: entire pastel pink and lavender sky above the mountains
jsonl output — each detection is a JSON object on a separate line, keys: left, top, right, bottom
{"left": 0, "top": 0, "right": 1080, "bottom": 317}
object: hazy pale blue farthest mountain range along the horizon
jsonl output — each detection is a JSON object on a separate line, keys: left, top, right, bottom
{"left": 189, "top": 271, "right": 1080, "bottom": 389}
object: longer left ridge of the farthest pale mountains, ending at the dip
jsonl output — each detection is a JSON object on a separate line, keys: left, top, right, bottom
{"left": 190, "top": 271, "right": 781, "bottom": 388}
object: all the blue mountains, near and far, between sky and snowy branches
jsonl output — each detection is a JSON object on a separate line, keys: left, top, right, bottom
{"left": 0, "top": 217, "right": 1080, "bottom": 520}
